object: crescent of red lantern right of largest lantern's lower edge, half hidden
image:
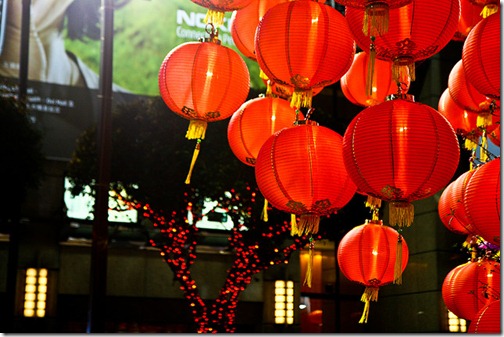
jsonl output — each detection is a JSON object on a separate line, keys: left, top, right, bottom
{"left": 438, "top": 170, "right": 475, "bottom": 235}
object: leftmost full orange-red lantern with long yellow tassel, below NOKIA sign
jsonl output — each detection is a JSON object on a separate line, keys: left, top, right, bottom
{"left": 158, "top": 32, "right": 250, "bottom": 183}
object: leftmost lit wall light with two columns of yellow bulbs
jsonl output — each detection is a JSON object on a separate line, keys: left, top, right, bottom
{"left": 23, "top": 268, "right": 48, "bottom": 317}
